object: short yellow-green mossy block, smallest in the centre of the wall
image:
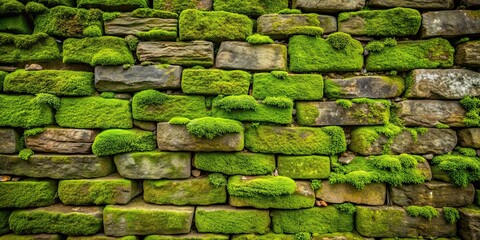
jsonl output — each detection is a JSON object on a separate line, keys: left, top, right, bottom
{"left": 277, "top": 155, "right": 330, "bottom": 179}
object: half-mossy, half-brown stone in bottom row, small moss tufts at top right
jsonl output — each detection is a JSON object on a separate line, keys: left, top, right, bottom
{"left": 355, "top": 206, "right": 457, "bottom": 237}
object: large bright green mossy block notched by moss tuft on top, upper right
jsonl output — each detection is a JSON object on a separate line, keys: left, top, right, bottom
{"left": 288, "top": 35, "right": 363, "bottom": 72}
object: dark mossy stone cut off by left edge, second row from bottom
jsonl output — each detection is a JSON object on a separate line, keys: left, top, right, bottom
{"left": 0, "top": 179, "right": 57, "bottom": 208}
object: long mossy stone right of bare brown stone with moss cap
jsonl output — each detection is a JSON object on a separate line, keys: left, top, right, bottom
{"left": 245, "top": 125, "right": 346, "bottom": 155}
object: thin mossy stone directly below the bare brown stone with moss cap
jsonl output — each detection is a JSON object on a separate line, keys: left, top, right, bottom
{"left": 193, "top": 152, "right": 275, "bottom": 176}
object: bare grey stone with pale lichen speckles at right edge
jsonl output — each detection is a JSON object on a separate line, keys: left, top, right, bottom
{"left": 405, "top": 69, "right": 480, "bottom": 99}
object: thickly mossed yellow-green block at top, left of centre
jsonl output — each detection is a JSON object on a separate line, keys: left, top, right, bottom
{"left": 179, "top": 9, "right": 253, "bottom": 42}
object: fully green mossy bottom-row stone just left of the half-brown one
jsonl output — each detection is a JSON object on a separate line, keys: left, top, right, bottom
{"left": 271, "top": 206, "right": 353, "bottom": 233}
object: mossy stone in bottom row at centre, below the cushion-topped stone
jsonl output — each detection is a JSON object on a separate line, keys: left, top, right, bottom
{"left": 195, "top": 205, "right": 270, "bottom": 234}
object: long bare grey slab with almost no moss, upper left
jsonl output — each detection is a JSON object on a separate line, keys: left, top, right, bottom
{"left": 95, "top": 65, "right": 182, "bottom": 92}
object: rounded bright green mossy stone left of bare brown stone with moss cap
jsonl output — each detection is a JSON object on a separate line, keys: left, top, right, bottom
{"left": 92, "top": 129, "right": 157, "bottom": 156}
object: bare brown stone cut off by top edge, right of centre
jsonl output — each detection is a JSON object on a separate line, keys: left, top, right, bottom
{"left": 292, "top": 0, "right": 365, "bottom": 13}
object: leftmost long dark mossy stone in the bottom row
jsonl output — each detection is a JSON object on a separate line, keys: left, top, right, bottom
{"left": 10, "top": 203, "right": 103, "bottom": 235}
